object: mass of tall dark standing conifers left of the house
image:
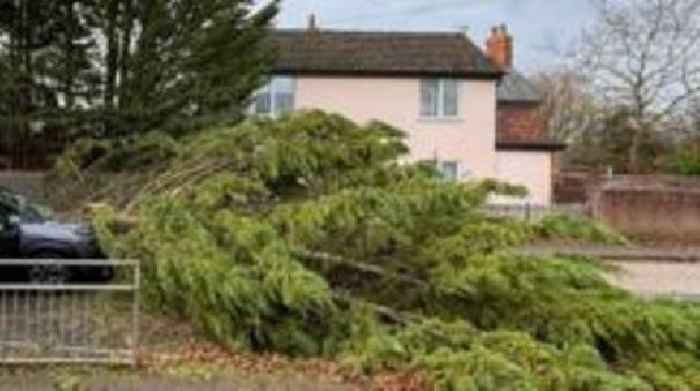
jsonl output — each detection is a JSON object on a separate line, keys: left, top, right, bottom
{"left": 0, "top": 0, "right": 278, "bottom": 166}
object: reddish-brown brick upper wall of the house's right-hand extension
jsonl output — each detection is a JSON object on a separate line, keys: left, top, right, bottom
{"left": 496, "top": 103, "right": 544, "bottom": 141}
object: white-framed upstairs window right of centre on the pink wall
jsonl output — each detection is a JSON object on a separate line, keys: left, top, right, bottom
{"left": 420, "top": 79, "right": 459, "bottom": 118}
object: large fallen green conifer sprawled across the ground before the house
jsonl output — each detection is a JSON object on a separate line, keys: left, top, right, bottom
{"left": 56, "top": 112, "right": 700, "bottom": 390}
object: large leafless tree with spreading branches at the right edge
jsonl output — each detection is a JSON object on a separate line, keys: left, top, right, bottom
{"left": 577, "top": 0, "right": 700, "bottom": 171}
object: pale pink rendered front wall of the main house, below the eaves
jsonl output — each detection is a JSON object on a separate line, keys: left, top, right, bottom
{"left": 295, "top": 77, "right": 497, "bottom": 178}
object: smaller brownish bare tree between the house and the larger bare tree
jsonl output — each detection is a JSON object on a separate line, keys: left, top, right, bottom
{"left": 531, "top": 67, "right": 601, "bottom": 142}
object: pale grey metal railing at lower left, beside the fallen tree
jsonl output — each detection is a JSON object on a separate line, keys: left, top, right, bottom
{"left": 0, "top": 259, "right": 140, "bottom": 365}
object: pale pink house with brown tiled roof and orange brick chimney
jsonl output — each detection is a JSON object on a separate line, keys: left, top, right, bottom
{"left": 251, "top": 16, "right": 564, "bottom": 205}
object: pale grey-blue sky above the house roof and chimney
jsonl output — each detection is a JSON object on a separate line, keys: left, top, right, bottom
{"left": 279, "top": 0, "right": 593, "bottom": 71}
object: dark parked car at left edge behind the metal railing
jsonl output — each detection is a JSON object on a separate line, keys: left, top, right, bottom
{"left": 0, "top": 188, "right": 113, "bottom": 284}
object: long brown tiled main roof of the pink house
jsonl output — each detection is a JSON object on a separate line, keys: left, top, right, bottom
{"left": 271, "top": 29, "right": 503, "bottom": 78}
